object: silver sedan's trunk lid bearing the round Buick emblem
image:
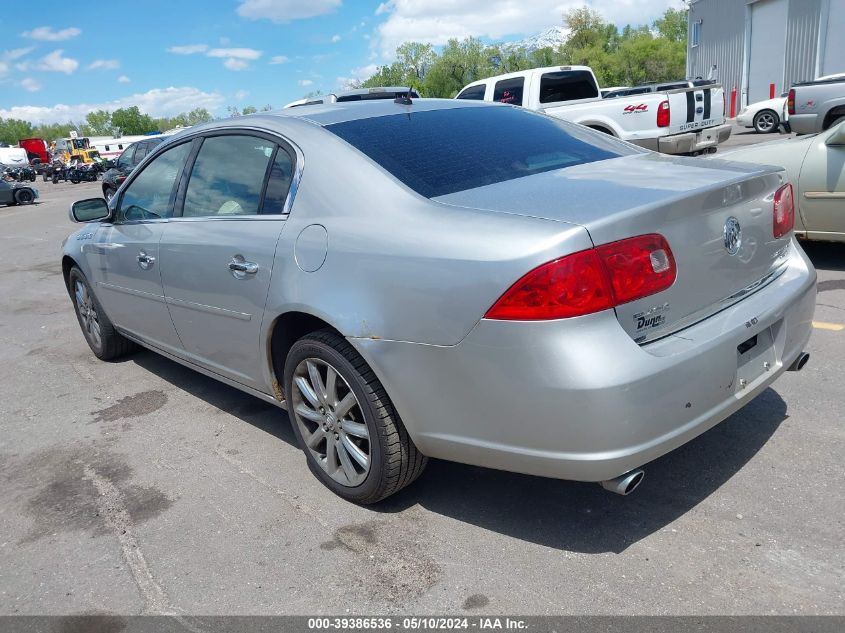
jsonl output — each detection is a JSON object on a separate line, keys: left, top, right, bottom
{"left": 436, "top": 154, "right": 790, "bottom": 342}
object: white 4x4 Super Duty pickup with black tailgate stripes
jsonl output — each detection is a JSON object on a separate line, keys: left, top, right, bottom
{"left": 456, "top": 66, "right": 731, "bottom": 154}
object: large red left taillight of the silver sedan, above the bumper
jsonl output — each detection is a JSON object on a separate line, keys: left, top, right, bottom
{"left": 484, "top": 234, "right": 677, "bottom": 321}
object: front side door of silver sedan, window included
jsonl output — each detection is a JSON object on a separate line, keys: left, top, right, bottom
{"left": 86, "top": 142, "right": 191, "bottom": 352}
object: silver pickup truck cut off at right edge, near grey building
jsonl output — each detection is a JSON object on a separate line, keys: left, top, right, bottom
{"left": 786, "top": 75, "right": 845, "bottom": 134}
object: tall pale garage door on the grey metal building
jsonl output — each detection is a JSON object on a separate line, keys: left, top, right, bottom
{"left": 748, "top": 0, "right": 789, "bottom": 103}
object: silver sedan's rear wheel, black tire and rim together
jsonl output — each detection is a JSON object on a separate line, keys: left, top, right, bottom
{"left": 285, "top": 330, "right": 428, "bottom": 504}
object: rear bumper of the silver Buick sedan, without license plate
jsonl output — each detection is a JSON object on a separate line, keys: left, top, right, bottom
{"left": 350, "top": 240, "right": 816, "bottom": 481}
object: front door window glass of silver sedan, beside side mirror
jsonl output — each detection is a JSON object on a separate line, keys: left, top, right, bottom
{"left": 115, "top": 142, "right": 191, "bottom": 222}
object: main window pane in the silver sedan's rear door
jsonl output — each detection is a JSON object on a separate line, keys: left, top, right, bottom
{"left": 182, "top": 135, "right": 276, "bottom": 218}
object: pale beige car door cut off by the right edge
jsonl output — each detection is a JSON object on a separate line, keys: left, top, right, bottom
{"left": 796, "top": 123, "right": 845, "bottom": 237}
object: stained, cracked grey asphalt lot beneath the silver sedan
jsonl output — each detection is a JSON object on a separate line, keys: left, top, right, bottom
{"left": 0, "top": 169, "right": 845, "bottom": 615}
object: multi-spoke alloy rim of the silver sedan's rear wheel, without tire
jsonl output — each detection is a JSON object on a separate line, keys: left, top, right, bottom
{"left": 290, "top": 358, "right": 372, "bottom": 487}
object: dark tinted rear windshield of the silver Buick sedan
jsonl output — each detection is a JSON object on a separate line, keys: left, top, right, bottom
{"left": 326, "top": 106, "right": 637, "bottom": 198}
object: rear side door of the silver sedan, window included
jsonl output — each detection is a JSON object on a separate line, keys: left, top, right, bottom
{"left": 160, "top": 132, "right": 295, "bottom": 389}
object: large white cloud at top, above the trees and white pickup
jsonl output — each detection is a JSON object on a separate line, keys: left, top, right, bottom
{"left": 373, "top": 0, "right": 678, "bottom": 59}
